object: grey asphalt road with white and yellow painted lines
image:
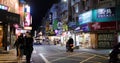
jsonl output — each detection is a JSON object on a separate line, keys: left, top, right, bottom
{"left": 32, "top": 45, "right": 108, "bottom": 63}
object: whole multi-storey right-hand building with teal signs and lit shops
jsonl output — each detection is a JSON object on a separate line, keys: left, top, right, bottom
{"left": 42, "top": 0, "right": 120, "bottom": 48}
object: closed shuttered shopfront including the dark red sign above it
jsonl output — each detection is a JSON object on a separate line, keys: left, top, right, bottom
{"left": 90, "top": 21, "right": 117, "bottom": 48}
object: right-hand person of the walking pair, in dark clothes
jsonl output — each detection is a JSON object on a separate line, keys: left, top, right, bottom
{"left": 25, "top": 32, "right": 33, "bottom": 63}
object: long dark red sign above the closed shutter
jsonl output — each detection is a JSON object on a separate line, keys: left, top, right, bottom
{"left": 89, "top": 22, "right": 116, "bottom": 30}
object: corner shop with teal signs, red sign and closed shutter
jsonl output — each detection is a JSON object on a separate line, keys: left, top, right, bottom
{"left": 79, "top": 7, "right": 117, "bottom": 48}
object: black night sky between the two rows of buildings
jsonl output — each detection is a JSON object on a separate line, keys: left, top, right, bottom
{"left": 29, "top": 0, "right": 57, "bottom": 30}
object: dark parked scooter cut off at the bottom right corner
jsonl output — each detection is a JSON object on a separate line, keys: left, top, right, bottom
{"left": 109, "top": 44, "right": 120, "bottom": 63}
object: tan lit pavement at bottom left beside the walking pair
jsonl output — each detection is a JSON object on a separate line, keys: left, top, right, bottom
{"left": 0, "top": 49, "right": 25, "bottom": 63}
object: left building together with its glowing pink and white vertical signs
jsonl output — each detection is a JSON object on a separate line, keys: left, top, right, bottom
{"left": 0, "top": 0, "right": 32, "bottom": 51}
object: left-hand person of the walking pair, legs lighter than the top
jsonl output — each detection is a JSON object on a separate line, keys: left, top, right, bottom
{"left": 14, "top": 34, "right": 24, "bottom": 61}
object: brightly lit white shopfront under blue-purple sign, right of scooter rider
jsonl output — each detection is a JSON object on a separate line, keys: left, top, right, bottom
{"left": 76, "top": 24, "right": 93, "bottom": 48}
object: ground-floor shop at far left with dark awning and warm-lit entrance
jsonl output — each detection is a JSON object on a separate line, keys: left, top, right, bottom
{"left": 0, "top": 10, "right": 20, "bottom": 50}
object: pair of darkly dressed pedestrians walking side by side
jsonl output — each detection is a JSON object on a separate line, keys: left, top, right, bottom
{"left": 14, "top": 32, "right": 33, "bottom": 63}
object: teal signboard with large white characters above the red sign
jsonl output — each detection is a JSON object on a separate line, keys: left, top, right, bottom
{"left": 92, "top": 7, "right": 116, "bottom": 22}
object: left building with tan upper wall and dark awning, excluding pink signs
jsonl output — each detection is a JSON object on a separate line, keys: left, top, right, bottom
{"left": 0, "top": 0, "right": 20, "bottom": 50}
